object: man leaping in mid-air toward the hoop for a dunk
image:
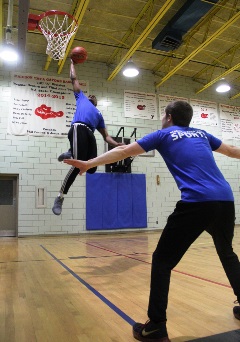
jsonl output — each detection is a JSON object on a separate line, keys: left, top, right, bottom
{"left": 52, "top": 60, "right": 122, "bottom": 215}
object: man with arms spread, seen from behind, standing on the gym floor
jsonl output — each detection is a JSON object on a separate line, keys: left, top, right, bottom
{"left": 64, "top": 101, "right": 240, "bottom": 342}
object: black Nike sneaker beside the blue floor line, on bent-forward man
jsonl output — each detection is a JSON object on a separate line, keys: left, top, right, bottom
{"left": 133, "top": 321, "right": 171, "bottom": 342}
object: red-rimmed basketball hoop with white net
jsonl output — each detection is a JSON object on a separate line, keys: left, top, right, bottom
{"left": 28, "top": 10, "right": 78, "bottom": 60}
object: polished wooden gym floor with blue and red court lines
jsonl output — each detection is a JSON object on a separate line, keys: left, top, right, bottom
{"left": 0, "top": 227, "right": 240, "bottom": 342}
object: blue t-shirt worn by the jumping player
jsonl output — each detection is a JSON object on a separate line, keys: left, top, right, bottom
{"left": 72, "top": 91, "right": 106, "bottom": 132}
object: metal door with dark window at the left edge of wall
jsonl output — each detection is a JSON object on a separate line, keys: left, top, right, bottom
{"left": 0, "top": 175, "right": 18, "bottom": 236}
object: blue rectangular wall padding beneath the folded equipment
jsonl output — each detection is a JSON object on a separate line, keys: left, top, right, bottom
{"left": 86, "top": 172, "right": 147, "bottom": 230}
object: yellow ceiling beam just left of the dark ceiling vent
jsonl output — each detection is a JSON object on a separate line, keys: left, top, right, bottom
{"left": 107, "top": 0, "right": 175, "bottom": 81}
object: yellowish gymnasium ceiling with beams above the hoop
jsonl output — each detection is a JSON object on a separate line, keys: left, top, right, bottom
{"left": 0, "top": 0, "right": 240, "bottom": 98}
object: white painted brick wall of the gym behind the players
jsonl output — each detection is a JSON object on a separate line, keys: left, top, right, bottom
{"left": 0, "top": 54, "right": 240, "bottom": 236}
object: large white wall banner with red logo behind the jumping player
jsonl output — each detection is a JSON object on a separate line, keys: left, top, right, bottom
{"left": 7, "top": 73, "right": 89, "bottom": 137}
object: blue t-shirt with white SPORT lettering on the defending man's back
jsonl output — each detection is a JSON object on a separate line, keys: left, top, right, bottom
{"left": 137, "top": 126, "right": 234, "bottom": 202}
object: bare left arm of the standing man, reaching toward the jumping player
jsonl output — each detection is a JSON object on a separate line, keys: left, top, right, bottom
{"left": 64, "top": 142, "right": 145, "bottom": 175}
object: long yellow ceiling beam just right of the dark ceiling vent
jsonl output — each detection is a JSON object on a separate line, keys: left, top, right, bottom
{"left": 156, "top": 12, "right": 240, "bottom": 87}
